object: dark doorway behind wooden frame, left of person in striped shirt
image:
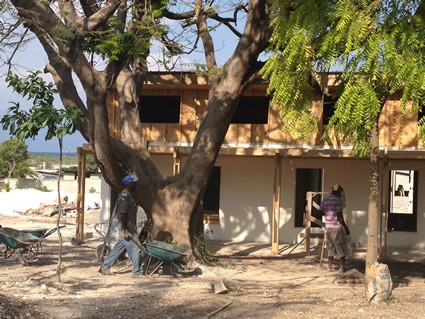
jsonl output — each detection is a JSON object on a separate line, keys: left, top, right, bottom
{"left": 295, "top": 168, "right": 322, "bottom": 227}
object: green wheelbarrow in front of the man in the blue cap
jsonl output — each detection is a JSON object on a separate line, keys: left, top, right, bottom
{"left": 131, "top": 237, "right": 194, "bottom": 277}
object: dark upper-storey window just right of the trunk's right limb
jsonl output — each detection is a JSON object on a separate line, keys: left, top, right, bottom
{"left": 231, "top": 96, "right": 270, "bottom": 124}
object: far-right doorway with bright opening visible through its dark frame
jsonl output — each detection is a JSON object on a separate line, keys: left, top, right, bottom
{"left": 388, "top": 170, "right": 418, "bottom": 232}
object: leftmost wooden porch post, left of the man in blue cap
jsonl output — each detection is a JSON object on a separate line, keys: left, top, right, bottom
{"left": 75, "top": 147, "right": 86, "bottom": 244}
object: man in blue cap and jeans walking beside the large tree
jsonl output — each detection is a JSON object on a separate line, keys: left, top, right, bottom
{"left": 100, "top": 175, "right": 143, "bottom": 277}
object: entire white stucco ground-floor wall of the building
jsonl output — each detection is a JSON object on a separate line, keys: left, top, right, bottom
{"left": 102, "top": 154, "right": 425, "bottom": 249}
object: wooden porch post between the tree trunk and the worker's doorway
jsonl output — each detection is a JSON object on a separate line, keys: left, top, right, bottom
{"left": 272, "top": 154, "right": 282, "bottom": 255}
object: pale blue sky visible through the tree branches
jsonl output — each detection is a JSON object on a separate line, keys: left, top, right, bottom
{"left": 0, "top": 9, "right": 244, "bottom": 153}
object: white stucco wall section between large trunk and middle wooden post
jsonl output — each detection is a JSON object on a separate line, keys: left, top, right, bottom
{"left": 205, "top": 156, "right": 274, "bottom": 242}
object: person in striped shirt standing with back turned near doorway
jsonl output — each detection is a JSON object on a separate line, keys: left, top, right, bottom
{"left": 320, "top": 184, "right": 350, "bottom": 273}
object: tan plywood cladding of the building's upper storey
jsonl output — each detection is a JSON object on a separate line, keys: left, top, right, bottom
{"left": 108, "top": 72, "right": 422, "bottom": 153}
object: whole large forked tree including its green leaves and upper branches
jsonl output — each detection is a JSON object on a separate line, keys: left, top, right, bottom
{"left": 2, "top": 0, "right": 271, "bottom": 255}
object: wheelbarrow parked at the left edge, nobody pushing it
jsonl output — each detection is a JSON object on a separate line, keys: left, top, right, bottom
{"left": 0, "top": 226, "right": 65, "bottom": 266}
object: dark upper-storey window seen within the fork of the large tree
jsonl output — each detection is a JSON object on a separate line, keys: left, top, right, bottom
{"left": 140, "top": 95, "right": 180, "bottom": 123}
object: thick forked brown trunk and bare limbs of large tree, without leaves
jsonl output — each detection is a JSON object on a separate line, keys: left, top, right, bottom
{"left": 12, "top": 0, "right": 271, "bottom": 262}
